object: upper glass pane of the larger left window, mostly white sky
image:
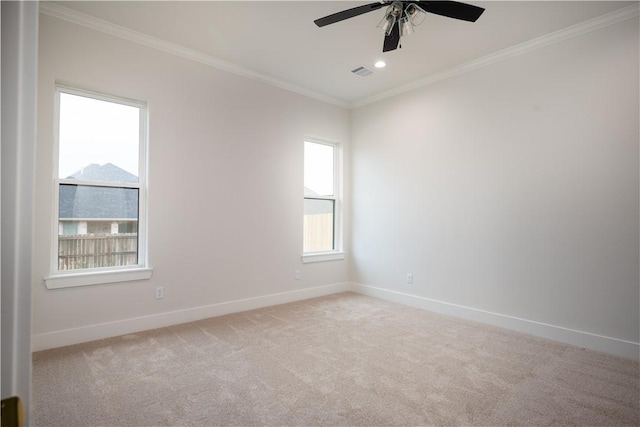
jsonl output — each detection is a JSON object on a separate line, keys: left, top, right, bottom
{"left": 58, "top": 93, "right": 140, "bottom": 183}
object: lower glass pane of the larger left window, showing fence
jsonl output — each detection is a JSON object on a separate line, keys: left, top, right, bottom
{"left": 58, "top": 184, "right": 139, "bottom": 270}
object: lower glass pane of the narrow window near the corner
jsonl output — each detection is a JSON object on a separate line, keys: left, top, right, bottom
{"left": 303, "top": 199, "right": 335, "bottom": 252}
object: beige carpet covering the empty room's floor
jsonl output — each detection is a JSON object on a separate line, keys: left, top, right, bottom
{"left": 32, "top": 293, "right": 640, "bottom": 426}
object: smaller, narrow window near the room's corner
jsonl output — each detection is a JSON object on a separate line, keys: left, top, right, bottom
{"left": 302, "top": 141, "right": 343, "bottom": 261}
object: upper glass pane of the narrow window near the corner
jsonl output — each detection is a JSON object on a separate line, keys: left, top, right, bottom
{"left": 304, "top": 141, "right": 334, "bottom": 196}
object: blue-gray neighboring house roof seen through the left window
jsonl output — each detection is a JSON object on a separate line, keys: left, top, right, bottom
{"left": 58, "top": 163, "right": 138, "bottom": 220}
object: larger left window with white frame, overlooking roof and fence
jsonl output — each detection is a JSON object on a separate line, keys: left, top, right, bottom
{"left": 46, "top": 86, "right": 150, "bottom": 288}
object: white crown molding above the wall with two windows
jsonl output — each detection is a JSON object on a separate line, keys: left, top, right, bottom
{"left": 40, "top": 1, "right": 351, "bottom": 108}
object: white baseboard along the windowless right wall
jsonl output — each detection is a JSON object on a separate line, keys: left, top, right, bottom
{"left": 349, "top": 283, "right": 640, "bottom": 361}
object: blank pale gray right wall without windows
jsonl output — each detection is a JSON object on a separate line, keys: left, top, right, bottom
{"left": 351, "top": 18, "right": 640, "bottom": 351}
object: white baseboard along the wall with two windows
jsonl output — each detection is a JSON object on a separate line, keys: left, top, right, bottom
{"left": 31, "top": 283, "right": 349, "bottom": 351}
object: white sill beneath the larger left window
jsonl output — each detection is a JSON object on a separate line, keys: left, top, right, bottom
{"left": 44, "top": 268, "right": 153, "bottom": 289}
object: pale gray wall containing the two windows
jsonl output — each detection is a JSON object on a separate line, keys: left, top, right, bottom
{"left": 33, "top": 15, "right": 349, "bottom": 349}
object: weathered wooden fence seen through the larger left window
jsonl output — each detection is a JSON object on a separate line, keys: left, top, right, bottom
{"left": 58, "top": 233, "right": 138, "bottom": 270}
